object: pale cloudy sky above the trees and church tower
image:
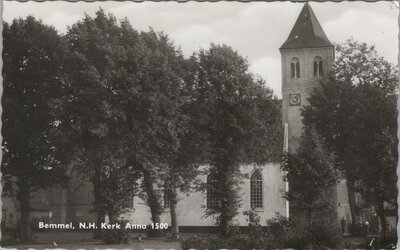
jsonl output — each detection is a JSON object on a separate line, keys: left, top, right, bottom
{"left": 3, "top": 1, "right": 399, "bottom": 98}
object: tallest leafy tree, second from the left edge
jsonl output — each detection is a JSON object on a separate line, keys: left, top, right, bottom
{"left": 56, "top": 10, "right": 140, "bottom": 227}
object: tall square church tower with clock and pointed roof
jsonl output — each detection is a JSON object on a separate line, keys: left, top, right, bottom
{"left": 279, "top": 3, "right": 334, "bottom": 152}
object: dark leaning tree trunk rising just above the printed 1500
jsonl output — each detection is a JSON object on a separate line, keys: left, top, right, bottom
{"left": 143, "top": 170, "right": 161, "bottom": 224}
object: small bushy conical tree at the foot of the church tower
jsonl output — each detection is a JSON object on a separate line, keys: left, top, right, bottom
{"left": 282, "top": 130, "right": 338, "bottom": 227}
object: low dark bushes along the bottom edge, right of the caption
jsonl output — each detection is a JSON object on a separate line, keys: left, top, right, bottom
{"left": 182, "top": 212, "right": 342, "bottom": 250}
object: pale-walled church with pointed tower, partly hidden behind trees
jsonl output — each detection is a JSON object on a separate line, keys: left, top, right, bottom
{"left": 2, "top": 3, "right": 350, "bottom": 235}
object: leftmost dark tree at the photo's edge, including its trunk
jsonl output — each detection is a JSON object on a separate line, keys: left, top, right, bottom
{"left": 2, "top": 16, "right": 71, "bottom": 241}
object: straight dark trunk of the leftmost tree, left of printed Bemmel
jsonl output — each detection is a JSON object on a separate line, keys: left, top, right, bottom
{"left": 18, "top": 185, "right": 32, "bottom": 243}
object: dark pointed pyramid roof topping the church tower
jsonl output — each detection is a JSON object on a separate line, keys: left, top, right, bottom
{"left": 280, "top": 2, "right": 333, "bottom": 49}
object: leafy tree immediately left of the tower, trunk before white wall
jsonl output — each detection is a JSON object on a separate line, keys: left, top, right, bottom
{"left": 196, "top": 44, "right": 281, "bottom": 235}
